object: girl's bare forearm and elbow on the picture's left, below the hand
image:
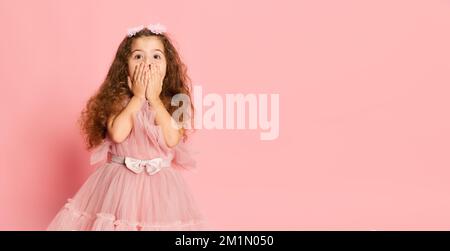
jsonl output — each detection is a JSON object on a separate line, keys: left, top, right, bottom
{"left": 107, "top": 96, "right": 145, "bottom": 143}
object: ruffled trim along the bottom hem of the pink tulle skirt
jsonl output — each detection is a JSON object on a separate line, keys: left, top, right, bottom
{"left": 48, "top": 198, "right": 205, "bottom": 231}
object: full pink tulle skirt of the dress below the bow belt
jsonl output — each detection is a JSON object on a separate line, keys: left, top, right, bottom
{"left": 47, "top": 163, "right": 206, "bottom": 231}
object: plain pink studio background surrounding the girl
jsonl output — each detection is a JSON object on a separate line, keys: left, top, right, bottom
{"left": 0, "top": 0, "right": 450, "bottom": 230}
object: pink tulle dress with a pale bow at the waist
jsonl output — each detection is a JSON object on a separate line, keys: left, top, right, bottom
{"left": 47, "top": 101, "right": 206, "bottom": 230}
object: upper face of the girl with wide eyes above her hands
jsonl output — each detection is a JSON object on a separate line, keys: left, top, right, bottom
{"left": 128, "top": 36, "right": 167, "bottom": 79}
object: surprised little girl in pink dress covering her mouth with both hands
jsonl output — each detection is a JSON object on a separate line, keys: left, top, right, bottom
{"left": 47, "top": 24, "right": 205, "bottom": 230}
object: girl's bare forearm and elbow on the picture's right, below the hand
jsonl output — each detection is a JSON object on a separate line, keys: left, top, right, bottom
{"left": 149, "top": 98, "right": 183, "bottom": 148}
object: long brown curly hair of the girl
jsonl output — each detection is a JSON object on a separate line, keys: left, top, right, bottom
{"left": 78, "top": 28, "right": 194, "bottom": 150}
